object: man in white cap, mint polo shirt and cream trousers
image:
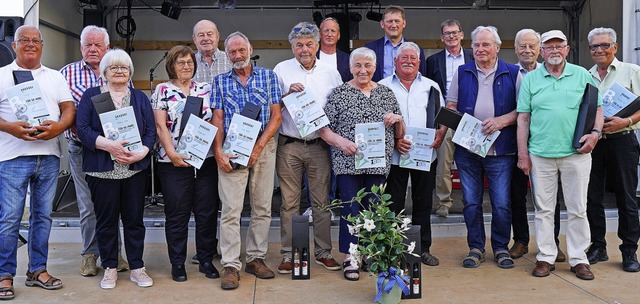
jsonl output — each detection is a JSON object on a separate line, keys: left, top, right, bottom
{"left": 517, "top": 30, "right": 603, "bottom": 280}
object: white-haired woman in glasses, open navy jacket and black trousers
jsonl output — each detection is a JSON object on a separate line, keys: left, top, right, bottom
{"left": 76, "top": 49, "right": 156, "bottom": 289}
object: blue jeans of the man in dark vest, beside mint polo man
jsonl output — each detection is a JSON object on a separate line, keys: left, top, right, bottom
{"left": 455, "top": 149, "right": 514, "bottom": 252}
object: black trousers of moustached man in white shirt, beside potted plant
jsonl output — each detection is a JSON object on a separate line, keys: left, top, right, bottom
{"left": 387, "top": 162, "right": 437, "bottom": 252}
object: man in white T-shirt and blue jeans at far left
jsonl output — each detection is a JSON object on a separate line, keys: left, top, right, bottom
{"left": 0, "top": 25, "right": 76, "bottom": 300}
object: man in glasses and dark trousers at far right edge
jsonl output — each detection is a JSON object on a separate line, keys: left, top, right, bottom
{"left": 587, "top": 27, "right": 640, "bottom": 272}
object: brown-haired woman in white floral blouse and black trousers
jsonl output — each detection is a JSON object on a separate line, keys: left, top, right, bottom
{"left": 151, "top": 45, "right": 220, "bottom": 282}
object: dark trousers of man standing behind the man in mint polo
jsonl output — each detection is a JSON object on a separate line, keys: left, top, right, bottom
{"left": 511, "top": 166, "right": 560, "bottom": 246}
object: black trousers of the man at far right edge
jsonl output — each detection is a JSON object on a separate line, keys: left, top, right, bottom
{"left": 587, "top": 132, "right": 640, "bottom": 252}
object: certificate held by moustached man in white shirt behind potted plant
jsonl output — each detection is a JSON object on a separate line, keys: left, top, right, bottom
{"left": 399, "top": 126, "right": 436, "bottom": 171}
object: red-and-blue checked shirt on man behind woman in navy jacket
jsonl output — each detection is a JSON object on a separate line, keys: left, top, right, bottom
{"left": 60, "top": 60, "right": 102, "bottom": 142}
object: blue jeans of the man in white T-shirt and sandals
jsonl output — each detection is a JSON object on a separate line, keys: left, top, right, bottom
{"left": 0, "top": 155, "right": 60, "bottom": 276}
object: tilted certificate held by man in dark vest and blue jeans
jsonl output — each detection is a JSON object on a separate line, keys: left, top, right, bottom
{"left": 452, "top": 113, "right": 500, "bottom": 157}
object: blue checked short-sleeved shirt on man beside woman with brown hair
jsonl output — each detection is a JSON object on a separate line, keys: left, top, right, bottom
{"left": 211, "top": 66, "right": 282, "bottom": 134}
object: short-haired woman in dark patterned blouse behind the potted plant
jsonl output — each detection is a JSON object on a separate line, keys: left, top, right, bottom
{"left": 320, "top": 47, "right": 405, "bottom": 281}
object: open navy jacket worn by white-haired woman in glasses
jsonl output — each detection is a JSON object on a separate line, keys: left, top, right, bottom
{"left": 76, "top": 87, "right": 156, "bottom": 172}
